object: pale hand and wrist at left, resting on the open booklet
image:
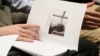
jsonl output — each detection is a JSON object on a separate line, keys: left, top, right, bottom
{"left": 0, "top": 24, "right": 40, "bottom": 42}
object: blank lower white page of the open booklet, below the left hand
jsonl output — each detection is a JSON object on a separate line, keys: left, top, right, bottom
{"left": 13, "top": 40, "right": 67, "bottom": 56}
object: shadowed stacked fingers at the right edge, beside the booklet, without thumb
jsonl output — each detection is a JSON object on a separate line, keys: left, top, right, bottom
{"left": 83, "top": 8, "right": 100, "bottom": 29}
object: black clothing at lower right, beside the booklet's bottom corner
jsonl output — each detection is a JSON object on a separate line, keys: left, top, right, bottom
{"left": 63, "top": 38, "right": 99, "bottom": 56}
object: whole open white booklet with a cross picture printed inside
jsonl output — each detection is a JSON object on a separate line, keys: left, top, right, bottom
{"left": 14, "top": 0, "right": 86, "bottom": 56}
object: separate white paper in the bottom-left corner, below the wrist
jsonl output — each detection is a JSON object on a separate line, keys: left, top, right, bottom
{"left": 0, "top": 35, "right": 18, "bottom": 56}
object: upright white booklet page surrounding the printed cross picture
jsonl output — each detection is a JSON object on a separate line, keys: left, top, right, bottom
{"left": 28, "top": 0, "right": 86, "bottom": 50}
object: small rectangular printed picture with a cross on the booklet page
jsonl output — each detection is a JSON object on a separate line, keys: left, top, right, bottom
{"left": 49, "top": 10, "right": 68, "bottom": 36}
